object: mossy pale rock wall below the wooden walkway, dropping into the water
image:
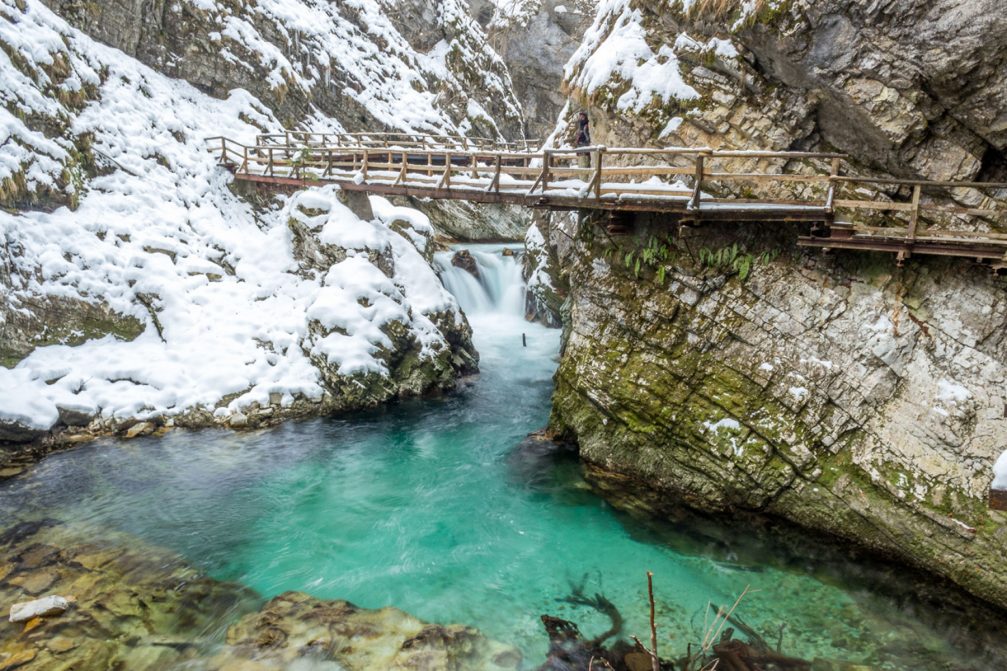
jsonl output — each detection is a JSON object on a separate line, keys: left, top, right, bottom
{"left": 552, "top": 215, "right": 1007, "bottom": 606}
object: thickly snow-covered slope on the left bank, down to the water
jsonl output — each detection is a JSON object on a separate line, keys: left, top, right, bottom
{"left": 0, "top": 0, "right": 475, "bottom": 437}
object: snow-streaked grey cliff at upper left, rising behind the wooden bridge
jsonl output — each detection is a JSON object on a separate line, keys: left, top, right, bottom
{"left": 39, "top": 0, "right": 523, "bottom": 138}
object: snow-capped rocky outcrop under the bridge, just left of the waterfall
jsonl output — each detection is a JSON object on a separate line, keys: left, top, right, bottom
{"left": 288, "top": 184, "right": 478, "bottom": 410}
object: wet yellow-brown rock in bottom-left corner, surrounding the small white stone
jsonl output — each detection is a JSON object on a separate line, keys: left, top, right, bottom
{"left": 0, "top": 521, "right": 260, "bottom": 670}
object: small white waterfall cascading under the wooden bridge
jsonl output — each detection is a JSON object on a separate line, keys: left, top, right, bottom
{"left": 435, "top": 245, "right": 525, "bottom": 318}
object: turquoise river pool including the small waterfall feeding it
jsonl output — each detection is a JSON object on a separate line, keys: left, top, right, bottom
{"left": 0, "top": 248, "right": 1003, "bottom": 671}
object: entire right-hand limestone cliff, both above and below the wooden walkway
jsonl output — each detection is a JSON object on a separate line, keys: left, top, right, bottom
{"left": 552, "top": 0, "right": 1007, "bottom": 606}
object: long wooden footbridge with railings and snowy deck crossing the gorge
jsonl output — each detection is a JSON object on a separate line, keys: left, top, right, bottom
{"left": 208, "top": 131, "right": 1007, "bottom": 272}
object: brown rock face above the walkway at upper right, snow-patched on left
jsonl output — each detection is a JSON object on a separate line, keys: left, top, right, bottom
{"left": 564, "top": 0, "right": 1007, "bottom": 180}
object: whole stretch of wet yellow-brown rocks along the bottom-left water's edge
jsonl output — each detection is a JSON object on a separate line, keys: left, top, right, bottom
{"left": 0, "top": 521, "right": 521, "bottom": 671}
